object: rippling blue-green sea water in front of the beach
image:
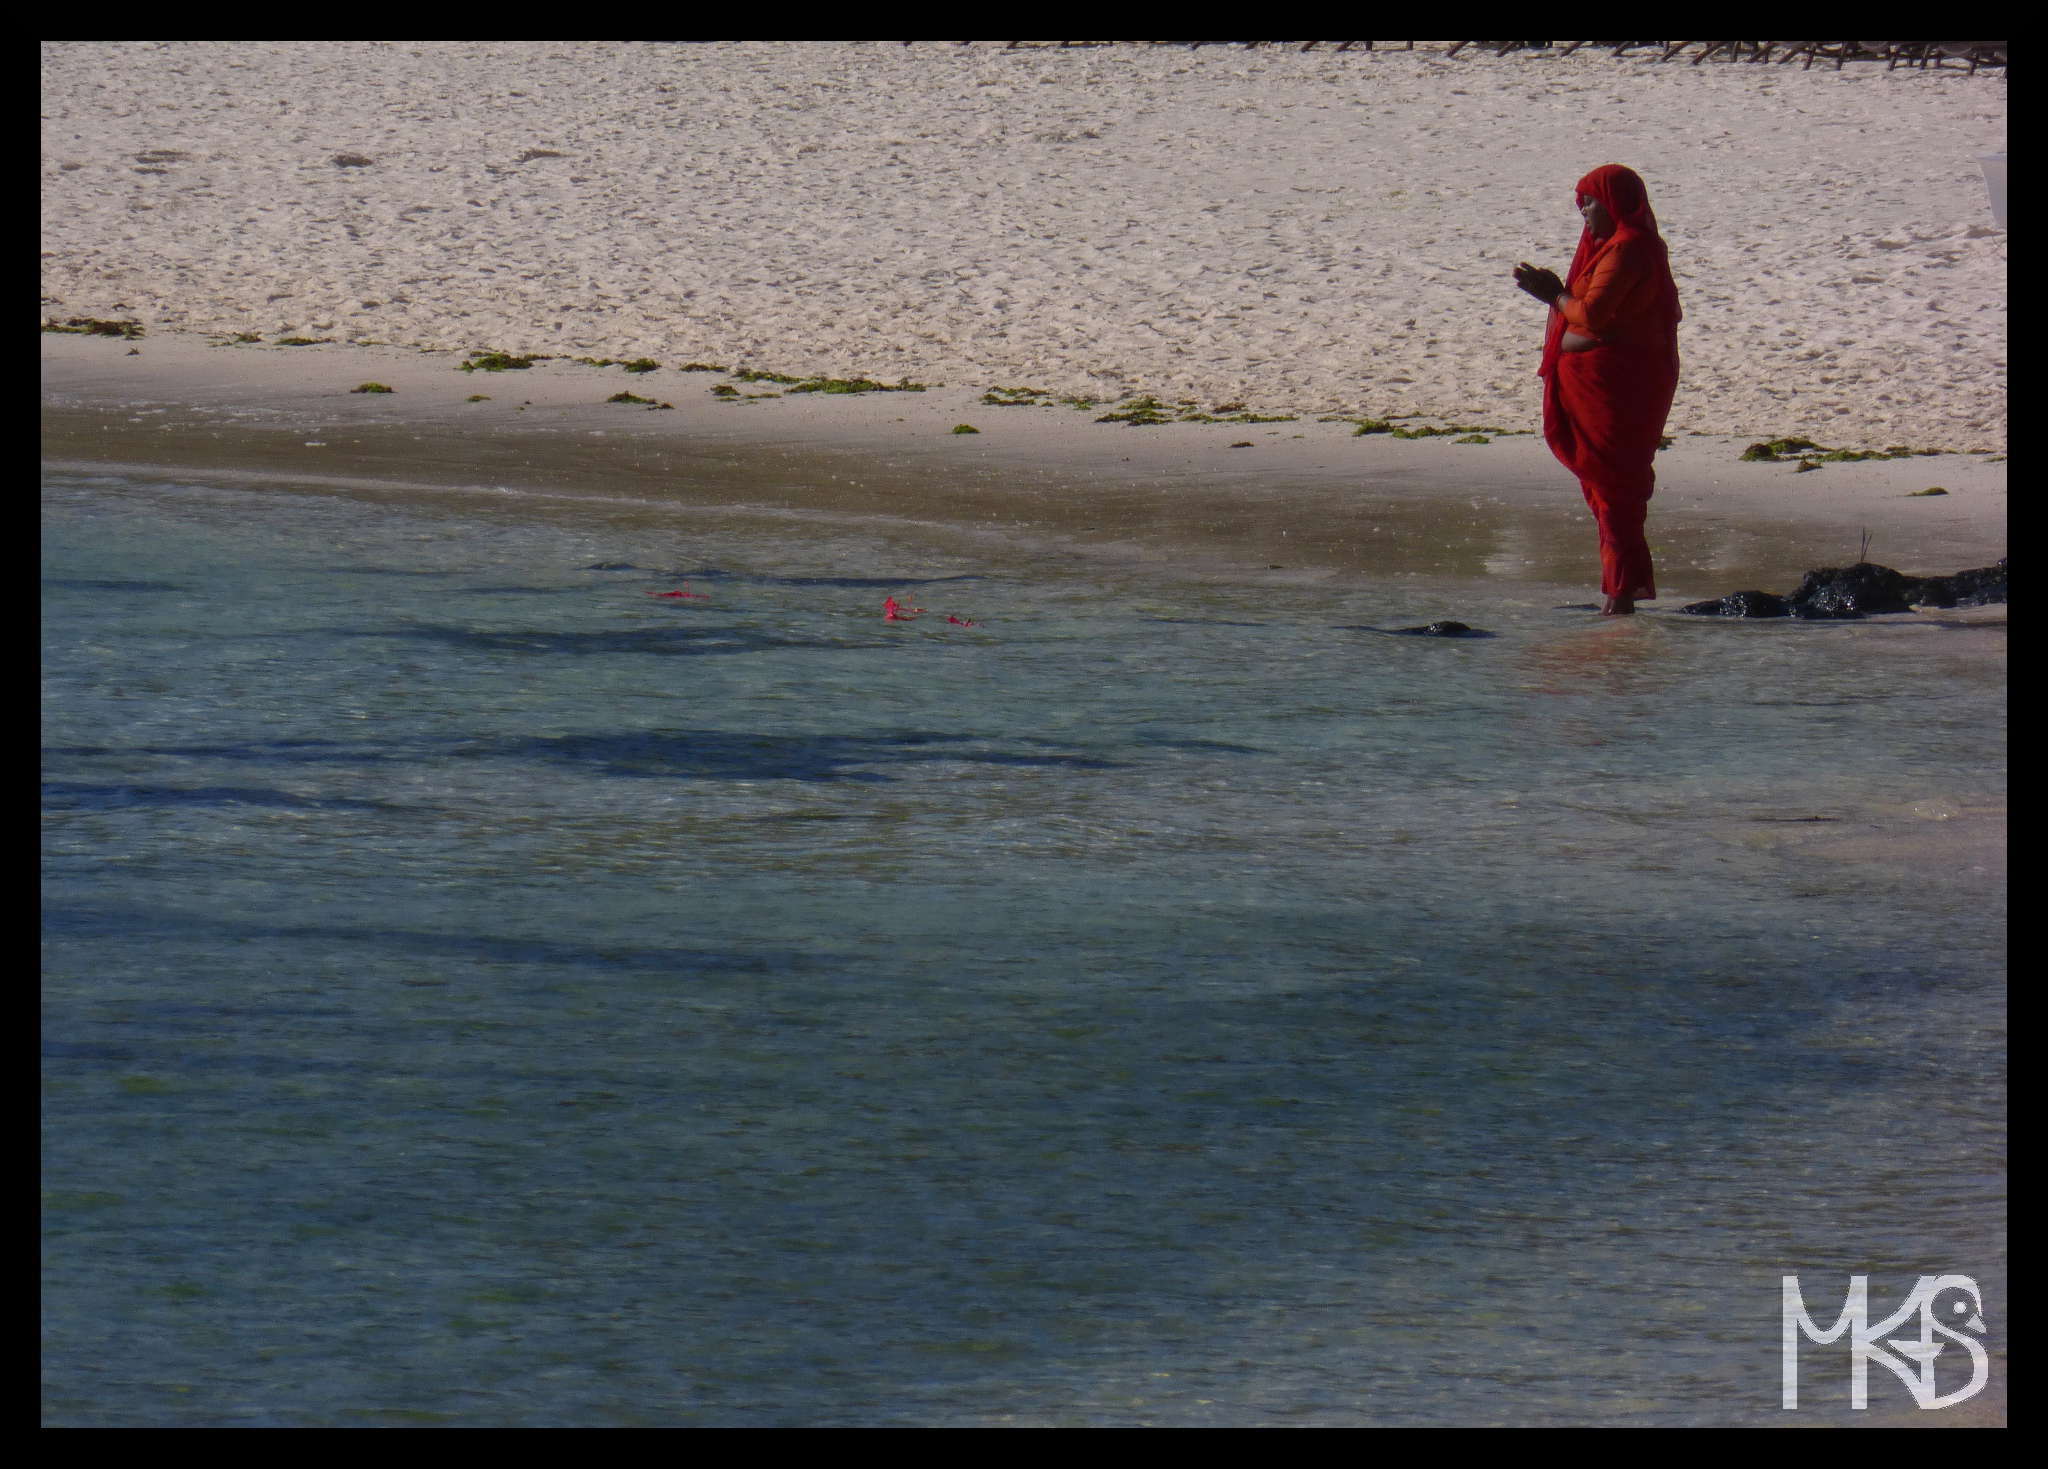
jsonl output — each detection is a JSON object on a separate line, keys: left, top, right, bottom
{"left": 43, "top": 460, "right": 2005, "bottom": 1426}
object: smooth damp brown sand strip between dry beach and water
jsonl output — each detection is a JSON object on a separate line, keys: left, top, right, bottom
{"left": 41, "top": 334, "right": 2005, "bottom": 606}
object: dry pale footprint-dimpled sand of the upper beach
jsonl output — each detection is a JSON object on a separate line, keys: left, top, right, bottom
{"left": 41, "top": 41, "right": 2007, "bottom": 451}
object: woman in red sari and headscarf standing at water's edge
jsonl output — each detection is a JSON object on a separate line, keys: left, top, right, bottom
{"left": 1516, "top": 164, "right": 1679, "bottom": 617}
